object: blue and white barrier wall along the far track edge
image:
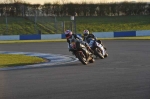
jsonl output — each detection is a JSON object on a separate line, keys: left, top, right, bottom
{"left": 0, "top": 30, "right": 150, "bottom": 40}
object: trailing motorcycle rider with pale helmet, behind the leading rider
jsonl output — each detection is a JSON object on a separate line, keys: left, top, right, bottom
{"left": 83, "top": 30, "right": 108, "bottom": 56}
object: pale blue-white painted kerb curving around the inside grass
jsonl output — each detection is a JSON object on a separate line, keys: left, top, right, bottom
{"left": 0, "top": 51, "right": 78, "bottom": 70}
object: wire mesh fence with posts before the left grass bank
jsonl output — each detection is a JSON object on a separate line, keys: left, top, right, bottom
{"left": 0, "top": 15, "right": 74, "bottom": 35}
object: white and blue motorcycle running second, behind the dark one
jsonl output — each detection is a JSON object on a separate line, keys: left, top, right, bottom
{"left": 88, "top": 38, "right": 108, "bottom": 59}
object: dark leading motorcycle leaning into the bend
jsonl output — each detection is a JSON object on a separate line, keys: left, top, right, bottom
{"left": 70, "top": 39, "right": 95, "bottom": 65}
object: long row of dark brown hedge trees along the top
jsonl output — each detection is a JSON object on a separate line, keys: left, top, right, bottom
{"left": 0, "top": 2, "right": 150, "bottom": 17}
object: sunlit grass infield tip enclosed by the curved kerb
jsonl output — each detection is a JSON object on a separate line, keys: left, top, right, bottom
{"left": 0, "top": 54, "right": 46, "bottom": 68}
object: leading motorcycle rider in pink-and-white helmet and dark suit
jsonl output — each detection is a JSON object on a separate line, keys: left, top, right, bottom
{"left": 65, "top": 30, "right": 93, "bottom": 54}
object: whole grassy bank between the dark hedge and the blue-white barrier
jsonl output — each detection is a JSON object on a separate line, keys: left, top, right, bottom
{"left": 0, "top": 15, "right": 150, "bottom": 35}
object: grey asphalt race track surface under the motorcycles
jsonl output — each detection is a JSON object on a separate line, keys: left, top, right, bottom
{"left": 0, "top": 40, "right": 150, "bottom": 99}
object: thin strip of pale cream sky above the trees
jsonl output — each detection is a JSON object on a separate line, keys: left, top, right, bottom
{"left": 0, "top": 0, "right": 150, "bottom": 4}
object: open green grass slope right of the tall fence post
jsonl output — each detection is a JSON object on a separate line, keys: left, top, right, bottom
{"left": 58, "top": 15, "right": 150, "bottom": 33}
